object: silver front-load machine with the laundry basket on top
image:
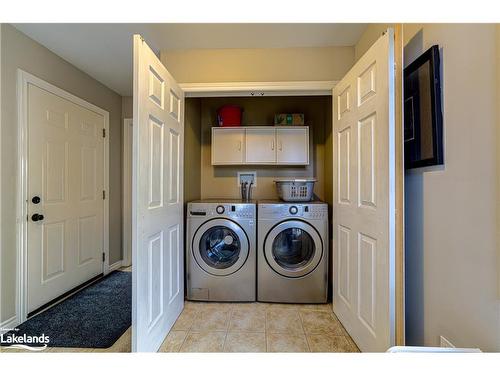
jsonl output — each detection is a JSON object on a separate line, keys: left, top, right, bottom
{"left": 257, "top": 201, "right": 328, "bottom": 303}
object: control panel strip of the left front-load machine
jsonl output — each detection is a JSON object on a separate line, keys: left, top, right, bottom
{"left": 187, "top": 202, "right": 257, "bottom": 219}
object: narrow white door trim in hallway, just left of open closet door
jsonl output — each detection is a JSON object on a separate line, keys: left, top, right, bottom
{"left": 122, "top": 118, "right": 133, "bottom": 267}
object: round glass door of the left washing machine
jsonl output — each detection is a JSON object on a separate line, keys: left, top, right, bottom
{"left": 192, "top": 219, "right": 249, "bottom": 276}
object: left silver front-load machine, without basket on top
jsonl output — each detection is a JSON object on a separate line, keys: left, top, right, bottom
{"left": 186, "top": 200, "right": 257, "bottom": 302}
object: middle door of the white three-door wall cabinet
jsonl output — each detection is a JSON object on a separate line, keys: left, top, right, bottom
{"left": 245, "top": 128, "right": 276, "bottom": 164}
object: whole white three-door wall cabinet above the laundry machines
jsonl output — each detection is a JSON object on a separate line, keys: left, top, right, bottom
{"left": 212, "top": 126, "right": 309, "bottom": 165}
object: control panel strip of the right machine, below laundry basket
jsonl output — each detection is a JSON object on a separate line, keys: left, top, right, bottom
{"left": 258, "top": 202, "right": 328, "bottom": 220}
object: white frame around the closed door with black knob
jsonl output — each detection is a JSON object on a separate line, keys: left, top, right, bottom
{"left": 16, "top": 69, "right": 109, "bottom": 324}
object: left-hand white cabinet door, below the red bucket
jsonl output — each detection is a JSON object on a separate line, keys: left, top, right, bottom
{"left": 212, "top": 128, "right": 245, "bottom": 165}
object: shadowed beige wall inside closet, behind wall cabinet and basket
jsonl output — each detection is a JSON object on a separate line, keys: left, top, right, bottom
{"left": 195, "top": 97, "right": 331, "bottom": 200}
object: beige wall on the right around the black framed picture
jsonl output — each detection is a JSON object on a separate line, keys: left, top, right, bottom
{"left": 404, "top": 24, "right": 500, "bottom": 351}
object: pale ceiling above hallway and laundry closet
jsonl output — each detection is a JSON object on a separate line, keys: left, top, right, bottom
{"left": 14, "top": 24, "right": 366, "bottom": 96}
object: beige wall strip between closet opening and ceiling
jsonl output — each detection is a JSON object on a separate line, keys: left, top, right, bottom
{"left": 160, "top": 47, "right": 354, "bottom": 83}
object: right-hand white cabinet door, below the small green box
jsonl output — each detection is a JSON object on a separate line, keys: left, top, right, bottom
{"left": 276, "top": 127, "right": 309, "bottom": 165}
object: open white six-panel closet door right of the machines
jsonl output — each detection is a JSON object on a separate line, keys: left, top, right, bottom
{"left": 333, "top": 29, "right": 396, "bottom": 351}
